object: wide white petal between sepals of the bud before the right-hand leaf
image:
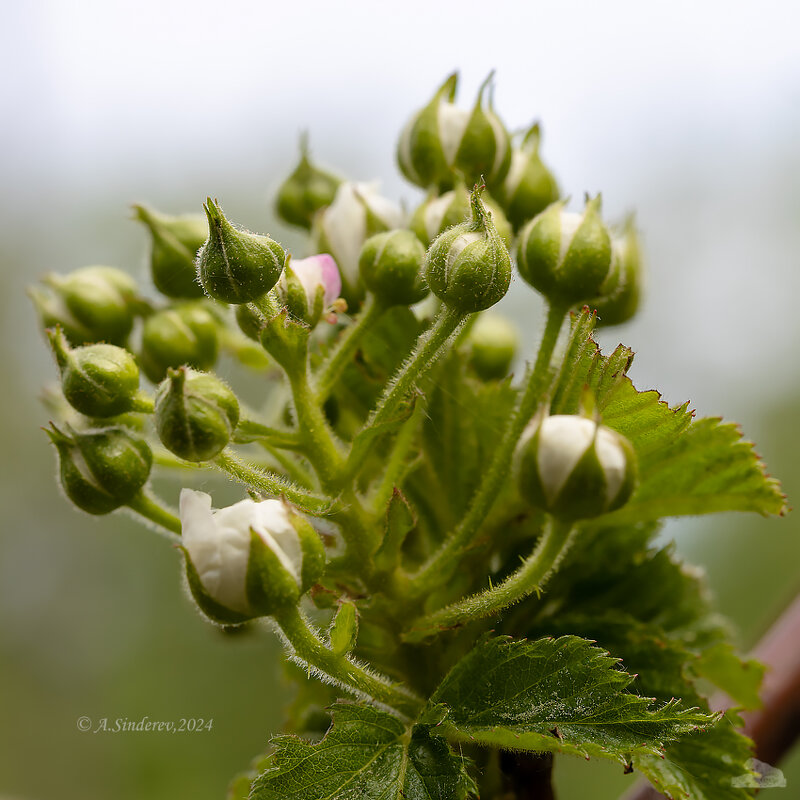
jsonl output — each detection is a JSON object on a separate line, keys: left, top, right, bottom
{"left": 536, "top": 415, "right": 597, "bottom": 502}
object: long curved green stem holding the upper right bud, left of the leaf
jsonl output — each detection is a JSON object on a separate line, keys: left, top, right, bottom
{"left": 407, "top": 306, "right": 567, "bottom": 599}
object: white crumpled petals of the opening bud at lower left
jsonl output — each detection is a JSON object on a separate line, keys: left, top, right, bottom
{"left": 180, "top": 489, "right": 303, "bottom": 615}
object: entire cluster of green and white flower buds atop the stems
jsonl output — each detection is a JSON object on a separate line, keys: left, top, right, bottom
{"left": 31, "top": 75, "right": 641, "bottom": 628}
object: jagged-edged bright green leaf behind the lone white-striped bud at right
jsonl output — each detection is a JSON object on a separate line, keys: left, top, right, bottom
{"left": 550, "top": 311, "right": 785, "bottom": 524}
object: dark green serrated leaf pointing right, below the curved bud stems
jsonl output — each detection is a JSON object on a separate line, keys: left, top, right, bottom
{"left": 431, "top": 636, "right": 716, "bottom": 765}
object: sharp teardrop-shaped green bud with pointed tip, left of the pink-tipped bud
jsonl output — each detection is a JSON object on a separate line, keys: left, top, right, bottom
{"left": 197, "top": 197, "right": 286, "bottom": 303}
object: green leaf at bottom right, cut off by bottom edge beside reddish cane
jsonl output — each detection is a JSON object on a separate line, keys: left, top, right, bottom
{"left": 633, "top": 719, "right": 758, "bottom": 800}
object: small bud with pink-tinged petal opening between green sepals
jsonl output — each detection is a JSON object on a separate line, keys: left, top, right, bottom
{"left": 278, "top": 253, "right": 342, "bottom": 328}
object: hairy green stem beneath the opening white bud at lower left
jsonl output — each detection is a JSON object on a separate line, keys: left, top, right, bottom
{"left": 275, "top": 606, "right": 423, "bottom": 719}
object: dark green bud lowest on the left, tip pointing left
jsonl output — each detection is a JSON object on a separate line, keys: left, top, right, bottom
{"left": 45, "top": 423, "right": 153, "bottom": 514}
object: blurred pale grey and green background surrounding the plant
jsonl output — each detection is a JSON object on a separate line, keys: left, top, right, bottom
{"left": 0, "top": 0, "right": 800, "bottom": 800}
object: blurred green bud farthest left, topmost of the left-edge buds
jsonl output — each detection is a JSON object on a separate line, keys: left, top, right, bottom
{"left": 31, "top": 267, "right": 137, "bottom": 345}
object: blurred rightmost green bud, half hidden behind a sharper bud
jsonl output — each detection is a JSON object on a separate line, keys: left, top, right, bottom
{"left": 588, "top": 218, "right": 642, "bottom": 325}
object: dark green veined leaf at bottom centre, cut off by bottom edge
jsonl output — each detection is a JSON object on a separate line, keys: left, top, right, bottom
{"left": 250, "top": 703, "right": 475, "bottom": 800}
